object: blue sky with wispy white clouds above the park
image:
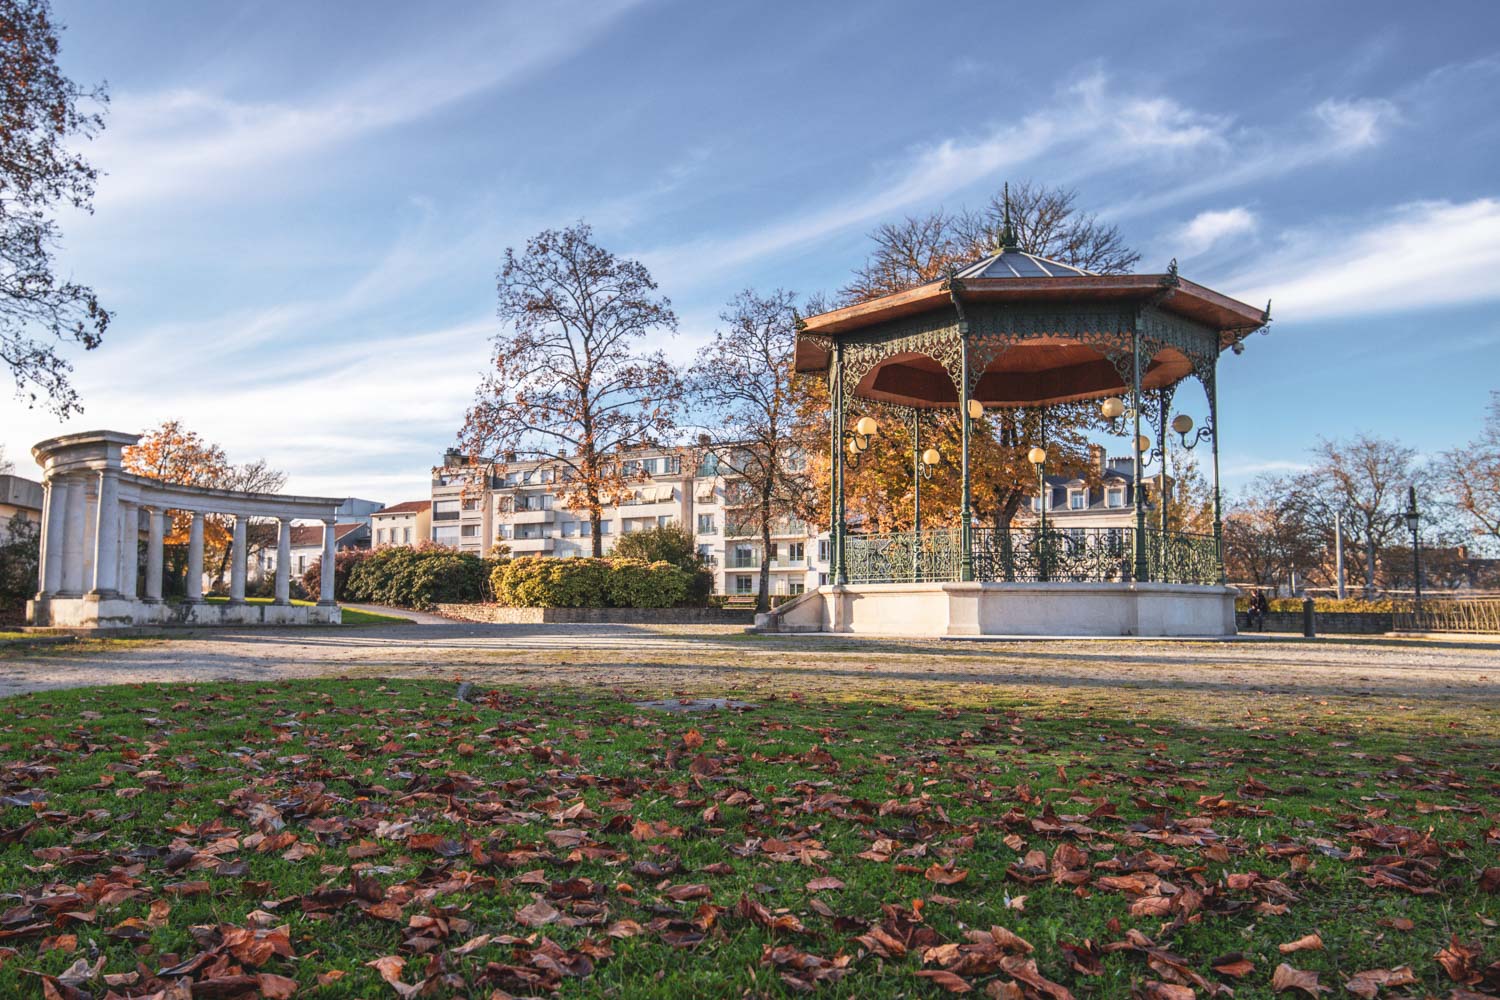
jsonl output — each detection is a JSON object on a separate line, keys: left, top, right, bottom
{"left": 0, "top": 0, "right": 1500, "bottom": 504}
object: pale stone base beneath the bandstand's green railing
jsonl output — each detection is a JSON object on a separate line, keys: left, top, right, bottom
{"left": 756, "top": 583, "right": 1238, "bottom": 639}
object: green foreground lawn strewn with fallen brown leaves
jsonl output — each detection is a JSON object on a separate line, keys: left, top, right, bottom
{"left": 0, "top": 679, "right": 1500, "bottom": 1000}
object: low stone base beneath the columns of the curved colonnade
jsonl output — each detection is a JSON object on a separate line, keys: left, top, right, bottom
{"left": 26, "top": 597, "right": 344, "bottom": 628}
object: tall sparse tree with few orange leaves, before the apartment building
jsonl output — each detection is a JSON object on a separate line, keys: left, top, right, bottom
{"left": 459, "top": 222, "right": 681, "bottom": 556}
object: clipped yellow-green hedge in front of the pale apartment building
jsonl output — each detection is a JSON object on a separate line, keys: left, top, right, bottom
{"left": 491, "top": 556, "right": 702, "bottom": 607}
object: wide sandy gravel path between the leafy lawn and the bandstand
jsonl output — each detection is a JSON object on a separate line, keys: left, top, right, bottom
{"left": 0, "top": 629, "right": 1500, "bottom": 721}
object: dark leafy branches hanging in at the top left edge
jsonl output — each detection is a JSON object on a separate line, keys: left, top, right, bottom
{"left": 0, "top": 0, "right": 110, "bottom": 417}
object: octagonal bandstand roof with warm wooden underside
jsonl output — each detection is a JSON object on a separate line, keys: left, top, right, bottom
{"left": 797, "top": 246, "right": 1269, "bottom": 408}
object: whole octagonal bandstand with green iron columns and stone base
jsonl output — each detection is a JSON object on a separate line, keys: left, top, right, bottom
{"left": 759, "top": 236, "right": 1271, "bottom": 636}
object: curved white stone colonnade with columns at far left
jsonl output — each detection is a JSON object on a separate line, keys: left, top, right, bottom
{"left": 27, "top": 430, "right": 342, "bottom": 628}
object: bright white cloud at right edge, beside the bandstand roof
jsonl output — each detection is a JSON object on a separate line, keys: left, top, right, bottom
{"left": 1217, "top": 198, "right": 1500, "bottom": 321}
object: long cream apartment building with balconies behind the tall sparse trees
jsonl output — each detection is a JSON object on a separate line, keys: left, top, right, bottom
{"left": 432, "top": 448, "right": 828, "bottom": 594}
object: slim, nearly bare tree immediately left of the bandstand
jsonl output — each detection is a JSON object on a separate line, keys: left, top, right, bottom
{"left": 693, "top": 289, "right": 809, "bottom": 610}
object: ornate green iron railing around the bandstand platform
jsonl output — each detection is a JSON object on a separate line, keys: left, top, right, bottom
{"left": 845, "top": 526, "right": 1220, "bottom": 583}
